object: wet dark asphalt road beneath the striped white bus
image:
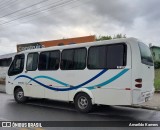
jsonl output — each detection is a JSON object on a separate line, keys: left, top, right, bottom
{"left": 0, "top": 93, "right": 160, "bottom": 130}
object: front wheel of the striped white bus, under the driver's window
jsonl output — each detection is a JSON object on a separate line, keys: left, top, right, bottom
{"left": 14, "top": 88, "right": 27, "bottom": 103}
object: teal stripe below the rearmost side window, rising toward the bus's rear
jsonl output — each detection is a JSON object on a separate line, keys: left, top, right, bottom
{"left": 86, "top": 69, "right": 129, "bottom": 90}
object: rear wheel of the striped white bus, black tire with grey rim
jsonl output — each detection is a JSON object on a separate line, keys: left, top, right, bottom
{"left": 74, "top": 93, "right": 92, "bottom": 113}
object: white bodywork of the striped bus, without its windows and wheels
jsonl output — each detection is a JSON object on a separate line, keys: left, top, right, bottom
{"left": 6, "top": 38, "right": 154, "bottom": 105}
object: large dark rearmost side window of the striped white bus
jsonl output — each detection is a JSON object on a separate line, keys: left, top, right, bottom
{"left": 88, "top": 43, "right": 126, "bottom": 69}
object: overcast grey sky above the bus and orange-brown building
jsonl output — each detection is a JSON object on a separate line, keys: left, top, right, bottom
{"left": 0, "top": 0, "right": 160, "bottom": 55}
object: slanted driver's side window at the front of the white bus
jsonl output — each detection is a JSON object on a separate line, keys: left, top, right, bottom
{"left": 8, "top": 54, "right": 24, "bottom": 76}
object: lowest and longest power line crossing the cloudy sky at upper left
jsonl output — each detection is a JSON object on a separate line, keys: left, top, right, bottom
{"left": 0, "top": 0, "right": 77, "bottom": 25}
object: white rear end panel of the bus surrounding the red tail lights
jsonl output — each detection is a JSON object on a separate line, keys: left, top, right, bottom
{"left": 130, "top": 41, "right": 155, "bottom": 104}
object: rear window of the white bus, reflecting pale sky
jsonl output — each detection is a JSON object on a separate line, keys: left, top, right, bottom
{"left": 139, "top": 43, "right": 153, "bottom": 66}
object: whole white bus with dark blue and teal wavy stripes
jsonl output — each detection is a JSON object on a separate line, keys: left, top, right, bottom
{"left": 6, "top": 38, "right": 154, "bottom": 112}
